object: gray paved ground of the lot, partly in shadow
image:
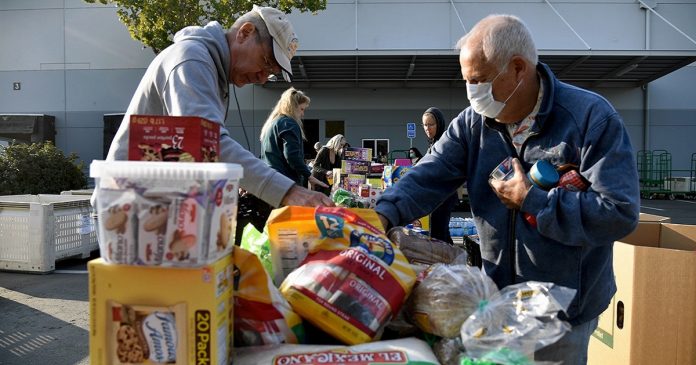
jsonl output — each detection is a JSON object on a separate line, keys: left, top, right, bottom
{"left": 0, "top": 200, "right": 696, "bottom": 365}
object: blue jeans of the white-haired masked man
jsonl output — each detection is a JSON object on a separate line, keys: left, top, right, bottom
{"left": 534, "top": 318, "right": 598, "bottom": 365}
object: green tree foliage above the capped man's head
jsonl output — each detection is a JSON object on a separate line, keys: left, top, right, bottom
{"left": 84, "top": 0, "right": 326, "bottom": 53}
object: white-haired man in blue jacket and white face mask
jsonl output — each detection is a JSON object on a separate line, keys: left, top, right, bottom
{"left": 376, "top": 15, "right": 639, "bottom": 364}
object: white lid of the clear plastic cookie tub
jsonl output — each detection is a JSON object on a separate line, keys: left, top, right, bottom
{"left": 89, "top": 160, "right": 244, "bottom": 180}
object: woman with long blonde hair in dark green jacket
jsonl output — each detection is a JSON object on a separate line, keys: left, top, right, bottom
{"left": 260, "top": 87, "right": 328, "bottom": 188}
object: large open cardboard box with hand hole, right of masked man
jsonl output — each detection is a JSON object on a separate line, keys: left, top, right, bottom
{"left": 588, "top": 222, "right": 696, "bottom": 365}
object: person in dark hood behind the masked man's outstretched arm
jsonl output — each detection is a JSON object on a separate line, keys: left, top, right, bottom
{"left": 421, "top": 107, "right": 459, "bottom": 244}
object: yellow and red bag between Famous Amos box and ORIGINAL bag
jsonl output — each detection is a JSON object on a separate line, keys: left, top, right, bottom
{"left": 234, "top": 247, "right": 304, "bottom": 346}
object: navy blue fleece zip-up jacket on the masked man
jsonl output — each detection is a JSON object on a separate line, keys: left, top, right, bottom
{"left": 376, "top": 63, "right": 639, "bottom": 325}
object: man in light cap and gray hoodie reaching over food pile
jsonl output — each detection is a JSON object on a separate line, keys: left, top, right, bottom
{"left": 107, "top": 5, "right": 333, "bottom": 207}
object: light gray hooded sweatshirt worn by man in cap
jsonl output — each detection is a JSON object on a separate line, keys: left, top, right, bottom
{"left": 106, "top": 22, "right": 294, "bottom": 207}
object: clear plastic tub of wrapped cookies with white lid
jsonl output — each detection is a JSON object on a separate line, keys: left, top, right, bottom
{"left": 90, "top": 161, "right": 242, "bottom": 266}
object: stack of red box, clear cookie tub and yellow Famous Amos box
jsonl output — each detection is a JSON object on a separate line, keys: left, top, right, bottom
{"left": 88, "top": 116, "right": 242, "bottom": 364}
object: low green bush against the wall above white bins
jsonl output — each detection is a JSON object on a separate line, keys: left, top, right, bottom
{"left": 0, "top": 142, "right": 87, "bottom": 195}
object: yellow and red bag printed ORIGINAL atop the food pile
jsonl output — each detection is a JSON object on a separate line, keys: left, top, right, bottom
{"left": 276, "top": 207, "right": 415, "bottom": 345}
